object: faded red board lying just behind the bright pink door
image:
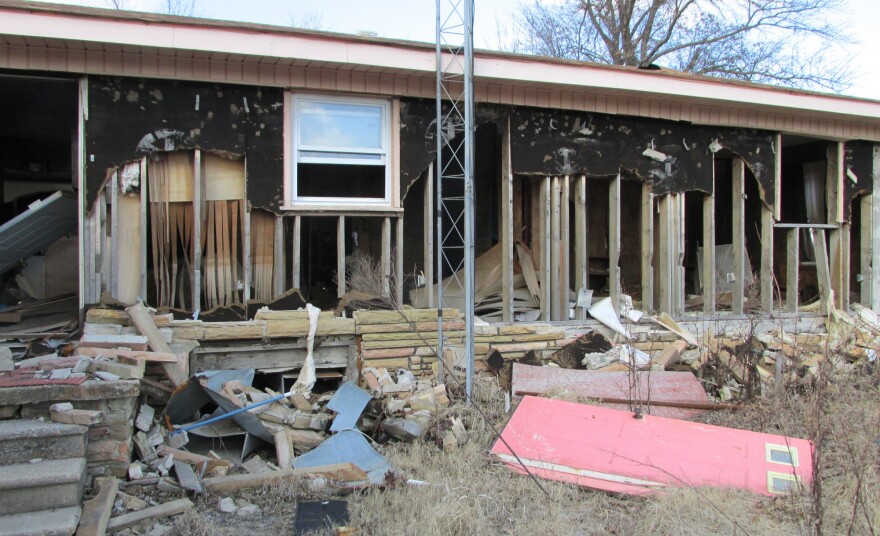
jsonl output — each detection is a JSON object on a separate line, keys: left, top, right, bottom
{"left": 511, "top": 363, "right": 710, "bottom": 419}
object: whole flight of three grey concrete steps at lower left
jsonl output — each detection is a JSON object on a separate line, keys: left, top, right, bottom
{"left": 0, "top": 420, "right": 88, "bottom": 536}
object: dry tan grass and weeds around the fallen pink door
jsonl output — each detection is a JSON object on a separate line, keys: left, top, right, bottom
{"left": 175, "top": 360, "right": 880, "bottom": 536}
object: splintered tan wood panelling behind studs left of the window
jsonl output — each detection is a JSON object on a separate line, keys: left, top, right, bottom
{"left": 148, "top": 151, "right": 247, "bottom": 309}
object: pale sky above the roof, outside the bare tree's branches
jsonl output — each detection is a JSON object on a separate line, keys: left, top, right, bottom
{"left": 27, "top": 0, "right": 880, "bottom": 100}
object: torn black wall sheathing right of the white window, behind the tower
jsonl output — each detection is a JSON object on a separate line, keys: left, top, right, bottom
{"left": 401, "top": 99, "right": 778, "bottom": 206}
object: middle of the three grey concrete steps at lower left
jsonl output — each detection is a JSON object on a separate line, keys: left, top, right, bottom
{"left": 0, "top": 458, "right": 86, "bottom": 515}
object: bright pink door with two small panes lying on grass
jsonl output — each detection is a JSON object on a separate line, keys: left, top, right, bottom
{"left": 491, "top": 396, "right": 813, "bottom": 495}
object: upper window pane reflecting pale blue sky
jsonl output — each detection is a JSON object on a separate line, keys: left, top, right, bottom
{"left": 298, "top": 100, "right": 382, "bottom": 149}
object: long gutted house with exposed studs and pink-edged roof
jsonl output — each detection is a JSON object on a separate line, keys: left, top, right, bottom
{"left": 0, "top": 0, "right": 880, "bottom": 532}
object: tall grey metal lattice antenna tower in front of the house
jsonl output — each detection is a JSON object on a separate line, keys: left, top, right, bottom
{"left": 436, "top": 0, "right": 474, "bottom": 402}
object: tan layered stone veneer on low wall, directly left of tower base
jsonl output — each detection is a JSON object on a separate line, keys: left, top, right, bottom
{"left": 354, "top": 309, "right": 464, "bottom": 375}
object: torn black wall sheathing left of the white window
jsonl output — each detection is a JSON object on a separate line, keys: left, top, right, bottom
{"left": 86, "top": 76, "right": 284, "bottom": 211}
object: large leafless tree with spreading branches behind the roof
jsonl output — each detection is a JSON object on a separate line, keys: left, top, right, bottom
{"left": 517, "top": 0, "right": 852, "bottom": 91}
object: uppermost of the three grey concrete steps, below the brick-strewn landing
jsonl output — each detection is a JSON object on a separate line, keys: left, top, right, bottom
{"left": 0, "top": 419, "right": 88, "bottom": 465}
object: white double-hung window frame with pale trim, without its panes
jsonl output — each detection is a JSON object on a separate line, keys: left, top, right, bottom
{"left": 285, "top": 93, "right": 395, "bottom": 208}
